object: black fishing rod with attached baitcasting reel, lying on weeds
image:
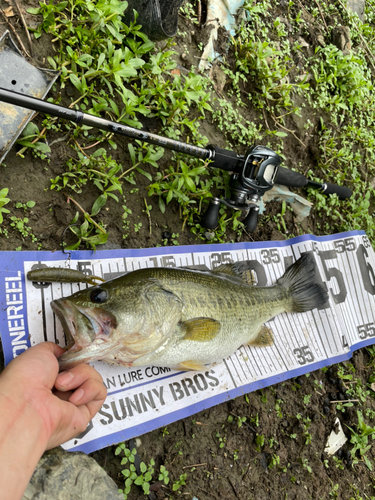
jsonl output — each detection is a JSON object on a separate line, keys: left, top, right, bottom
{"left": 0, "top": 87, "right": 352, "bottom": 232}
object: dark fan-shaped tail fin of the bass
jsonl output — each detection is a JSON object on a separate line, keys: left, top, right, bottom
{"left": 277, "top": 253, "right": 328, "bottom": 312}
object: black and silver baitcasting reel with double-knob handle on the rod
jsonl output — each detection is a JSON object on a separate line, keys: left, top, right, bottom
{"left": 202, "top": 146, "right": 281, "bottom": 232}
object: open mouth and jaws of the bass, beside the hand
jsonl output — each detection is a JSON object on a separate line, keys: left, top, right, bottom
{"left": 51, "top": 298, "right": 117, "bottom": 369}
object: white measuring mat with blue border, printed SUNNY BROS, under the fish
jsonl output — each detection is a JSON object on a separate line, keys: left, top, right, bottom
{"left": 0, "top": 231, "right": 375, "bottom": 453}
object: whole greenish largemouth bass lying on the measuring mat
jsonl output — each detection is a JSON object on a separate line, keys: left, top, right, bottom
{"left": 51, "top": 253, "right": 328, "bottom": 371}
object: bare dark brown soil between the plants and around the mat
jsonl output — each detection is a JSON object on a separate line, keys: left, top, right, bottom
{"left": 0, "top": 0, "right": 375, "bottom": 500}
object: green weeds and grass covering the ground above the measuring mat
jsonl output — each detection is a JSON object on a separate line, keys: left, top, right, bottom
{"left": 2, "top": 0, "right": 375, "bottom": 248}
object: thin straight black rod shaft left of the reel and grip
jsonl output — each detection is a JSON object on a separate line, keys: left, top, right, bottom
{"left": 0, "top": 87, "right": 212, "bottom": 160}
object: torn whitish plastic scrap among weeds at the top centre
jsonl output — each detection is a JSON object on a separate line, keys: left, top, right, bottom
{"left": 199, "top": 0, "right": 244, "bottom": 70}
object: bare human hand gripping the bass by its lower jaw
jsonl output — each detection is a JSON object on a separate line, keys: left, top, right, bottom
{"left": 0, "top": 342, "right": 107, "bottom": 450}
